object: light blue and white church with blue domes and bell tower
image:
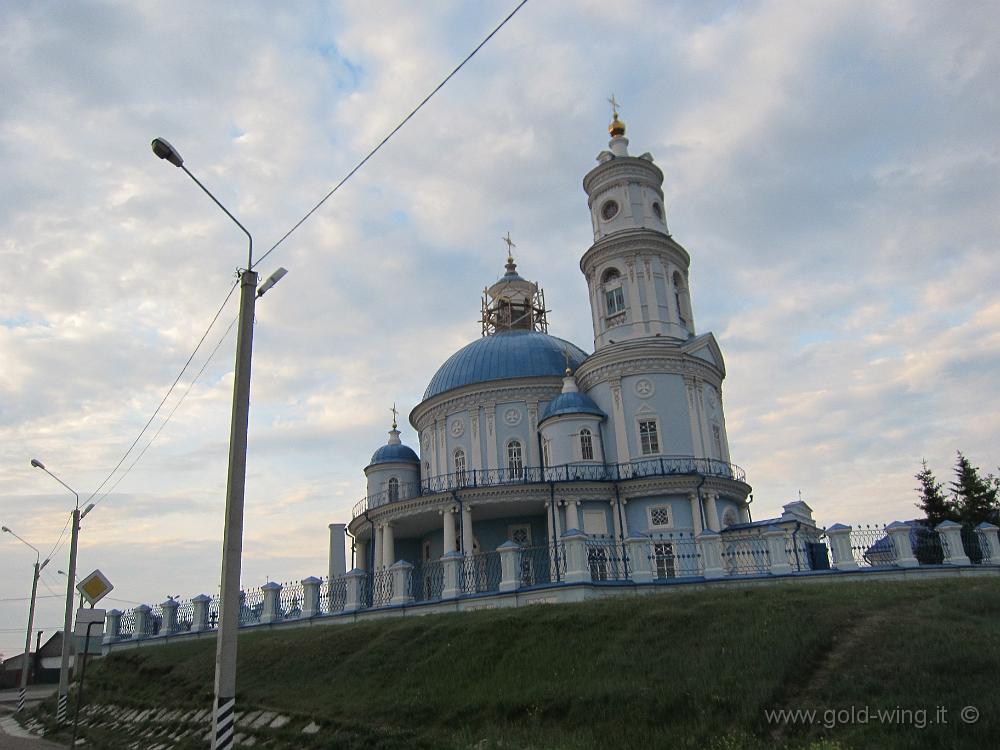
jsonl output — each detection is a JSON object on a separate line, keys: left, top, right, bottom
{"left": 330, "top": 108, "right": 780, "bottom": 600}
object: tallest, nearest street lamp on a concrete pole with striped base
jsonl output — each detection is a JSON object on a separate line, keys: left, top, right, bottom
{"left": 151, "top": 138, "right": 287, "bottom": 750}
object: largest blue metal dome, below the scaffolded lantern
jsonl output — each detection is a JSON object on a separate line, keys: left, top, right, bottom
{"left": 424, "top": 331, "right": 587, "bottom": 400}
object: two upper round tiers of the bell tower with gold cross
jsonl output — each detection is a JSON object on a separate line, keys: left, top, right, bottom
{"left": 580, "top": 96, "right": 695, "bottom": 351}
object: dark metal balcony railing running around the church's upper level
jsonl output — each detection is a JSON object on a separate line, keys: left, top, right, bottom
{"left": 351, "top": 456, "right": 746, "bottom": 518}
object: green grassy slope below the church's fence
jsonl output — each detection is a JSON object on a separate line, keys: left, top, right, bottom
{"left": 23, "top": 578, "right": 1000, "bottom": 750}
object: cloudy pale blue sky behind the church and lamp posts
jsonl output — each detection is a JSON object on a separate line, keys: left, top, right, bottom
{"left": 0, "top": 0, "right": 1000, "bottom": 655}
